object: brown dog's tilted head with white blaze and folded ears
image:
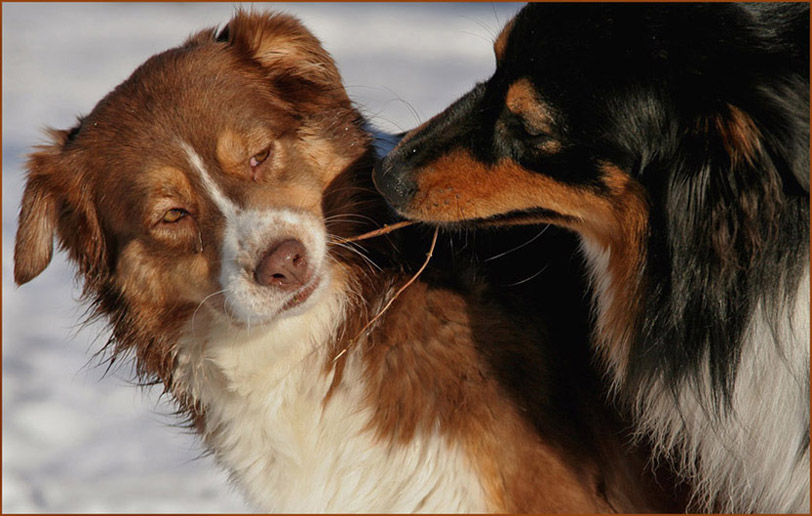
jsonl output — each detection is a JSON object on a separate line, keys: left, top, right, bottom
{"left": 14, "top": 12, "right": 369, "bottom": 382}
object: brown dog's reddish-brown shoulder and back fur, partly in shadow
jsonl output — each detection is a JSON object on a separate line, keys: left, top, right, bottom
{"left": 358, "top": 278, "right": 672, "bottom": 513}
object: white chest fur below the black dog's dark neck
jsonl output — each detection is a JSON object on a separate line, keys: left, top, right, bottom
{"left": 582, "top": 232, "right": 809, "bottom": 513}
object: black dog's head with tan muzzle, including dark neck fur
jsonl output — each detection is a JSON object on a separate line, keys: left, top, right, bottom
{"left": 375, "top": 4, "right": 809, "bottom": 402}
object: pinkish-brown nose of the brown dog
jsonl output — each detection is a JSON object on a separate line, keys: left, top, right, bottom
{"left": 254, "top": 240, "right": 312, "bottom": 290}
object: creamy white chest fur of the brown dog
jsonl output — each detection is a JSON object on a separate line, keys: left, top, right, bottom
{"left": 177, "top": 280, "right": 487, "bottom": 512}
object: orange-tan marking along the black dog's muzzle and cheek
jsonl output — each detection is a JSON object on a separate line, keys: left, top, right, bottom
{"left": 400, "top": 151, "right": 647, "bottom": 247}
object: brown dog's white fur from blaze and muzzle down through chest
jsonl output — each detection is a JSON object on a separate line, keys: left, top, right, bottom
{"left": 173, "top": 141, "right": 489, "bottom": 512}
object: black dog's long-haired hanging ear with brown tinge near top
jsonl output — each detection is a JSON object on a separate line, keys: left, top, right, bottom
{"left": 643, "top": 104, "right": 809, "bottom": 403}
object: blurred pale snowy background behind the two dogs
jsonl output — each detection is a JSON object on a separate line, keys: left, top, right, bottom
{"left": 2, "top": 3, "right": 520, "bottom": 513}
